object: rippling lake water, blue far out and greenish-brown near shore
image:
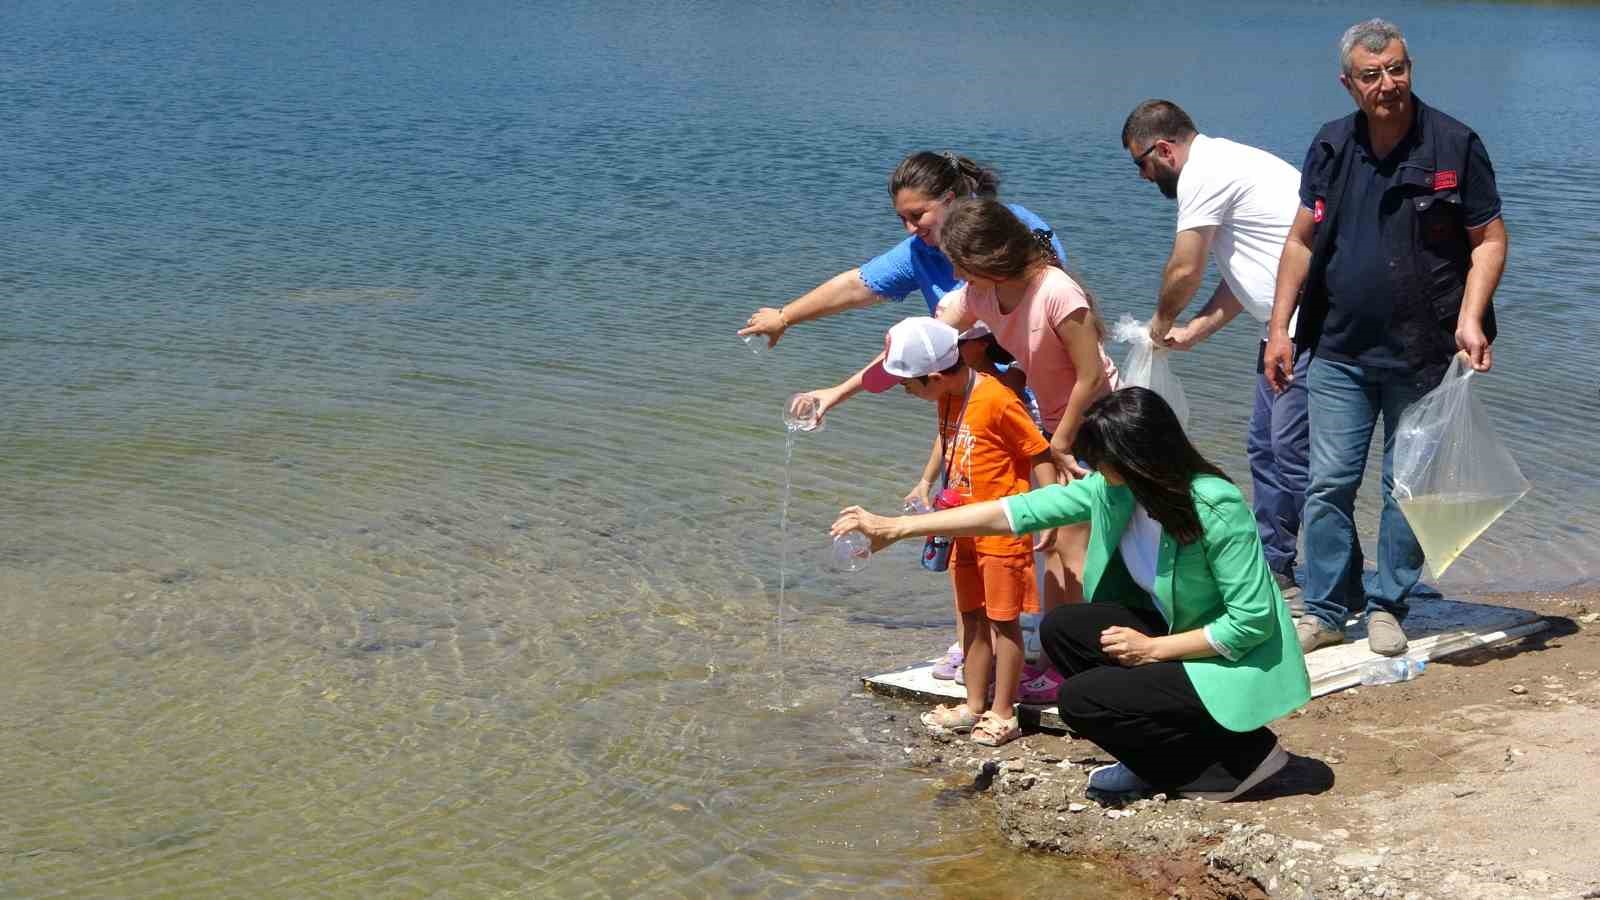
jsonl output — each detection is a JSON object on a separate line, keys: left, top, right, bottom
{"left": 0, "top": 0, "right": 1600, "bottom": 897}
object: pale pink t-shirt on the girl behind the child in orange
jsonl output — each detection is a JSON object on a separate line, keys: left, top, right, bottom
{"left": 939, "top": 266, "right": 1117, "bottom": 432}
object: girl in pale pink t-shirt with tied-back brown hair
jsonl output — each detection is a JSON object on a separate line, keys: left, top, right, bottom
{"left": 938, "top": 197, "right": 1117, "bottom": 700}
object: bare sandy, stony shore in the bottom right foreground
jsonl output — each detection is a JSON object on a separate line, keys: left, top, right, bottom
{"left": 896, "top": 586, "right": 1600, "bottom": 900}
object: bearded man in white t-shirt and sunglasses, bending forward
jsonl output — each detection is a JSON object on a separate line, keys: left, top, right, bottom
{"left": 1122, "top": 99, "right": 1310, "bottom": 617}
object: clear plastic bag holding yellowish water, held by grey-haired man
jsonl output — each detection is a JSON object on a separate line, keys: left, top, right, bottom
{"left": 1394, "top": 352, "right": 1531, "bottom": 578}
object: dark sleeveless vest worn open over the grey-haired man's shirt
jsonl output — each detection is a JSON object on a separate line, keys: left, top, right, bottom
{"left": 1294, "top": 94, "right": 1496, "bottom": 370}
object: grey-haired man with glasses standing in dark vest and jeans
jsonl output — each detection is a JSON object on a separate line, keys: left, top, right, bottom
{"left": 1264, "top": 19, "right": 1506, "bottom": 657}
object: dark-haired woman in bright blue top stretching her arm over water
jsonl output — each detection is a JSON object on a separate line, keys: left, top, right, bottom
{"left": 739, "top": 151, "right": 1067, "bottom": 346}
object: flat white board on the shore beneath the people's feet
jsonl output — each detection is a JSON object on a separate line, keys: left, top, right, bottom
{"left": 861, "top": 599, "right": 1547, "bottom": 729}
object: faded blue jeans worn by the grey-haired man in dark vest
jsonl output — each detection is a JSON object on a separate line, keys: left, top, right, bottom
{"left": 1304, "top": 359, "right": 1434, "bottom": 631}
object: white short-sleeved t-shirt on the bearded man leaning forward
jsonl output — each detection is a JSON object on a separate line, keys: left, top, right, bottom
{"left": 1178, "top": 135, "right": 1301, "bottom": 335}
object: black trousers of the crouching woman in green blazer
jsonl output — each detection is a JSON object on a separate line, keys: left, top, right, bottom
{"left": 1038, "top": 604, "right": 1277, "bottom": 790}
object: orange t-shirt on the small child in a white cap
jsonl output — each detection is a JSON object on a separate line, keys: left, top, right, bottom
{"left": 939, "top": 373, "right": 1050, "bottom": 556}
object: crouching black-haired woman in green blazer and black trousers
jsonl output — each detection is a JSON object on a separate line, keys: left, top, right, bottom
{"left": 832, "top": 388, "right": 1310, "bottom": 799}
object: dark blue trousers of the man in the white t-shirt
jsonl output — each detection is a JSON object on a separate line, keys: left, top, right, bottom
{"left": 1245, "top": 342, "right": 1310, "bottom": 575}
